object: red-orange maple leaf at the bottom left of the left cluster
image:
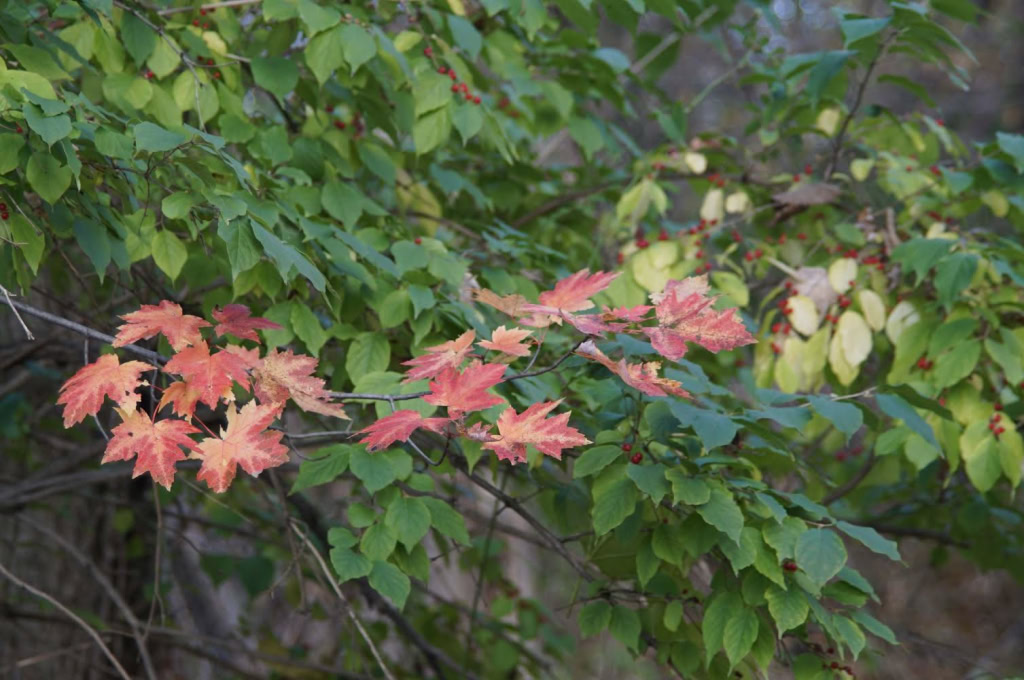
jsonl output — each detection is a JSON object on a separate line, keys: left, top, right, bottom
{"left": 102, "top": 409, "right": 199, "bottom": 490}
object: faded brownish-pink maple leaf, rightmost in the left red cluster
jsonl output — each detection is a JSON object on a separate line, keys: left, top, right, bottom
{"left": 252, "top": 349, "right": 348, "bottom": 420}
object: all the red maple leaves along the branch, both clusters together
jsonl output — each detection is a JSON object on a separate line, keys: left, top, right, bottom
{"left": 58, "top": 269, "right": 755, "bottom": 492}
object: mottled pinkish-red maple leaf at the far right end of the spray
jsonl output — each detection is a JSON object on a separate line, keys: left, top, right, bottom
{"left": 643, "top": 274, "right": 757, "bottom": 360}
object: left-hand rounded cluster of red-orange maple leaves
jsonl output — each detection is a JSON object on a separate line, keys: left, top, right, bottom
{"left": 57, "top": 300, "right": 347, "bottom": 492}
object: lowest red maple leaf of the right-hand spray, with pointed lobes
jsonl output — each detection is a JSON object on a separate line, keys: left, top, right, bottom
{"left": 482, "top": 399, "right": 590, "bottom": 465}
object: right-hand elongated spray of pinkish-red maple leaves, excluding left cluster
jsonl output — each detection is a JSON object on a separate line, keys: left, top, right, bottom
{"left": 359, "top": 269, "right": 755, "bottom": 464}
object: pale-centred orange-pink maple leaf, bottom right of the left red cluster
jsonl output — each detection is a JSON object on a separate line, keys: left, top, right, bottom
{"left": 189, "top": 401, "right": 288, "bottom": 494}
